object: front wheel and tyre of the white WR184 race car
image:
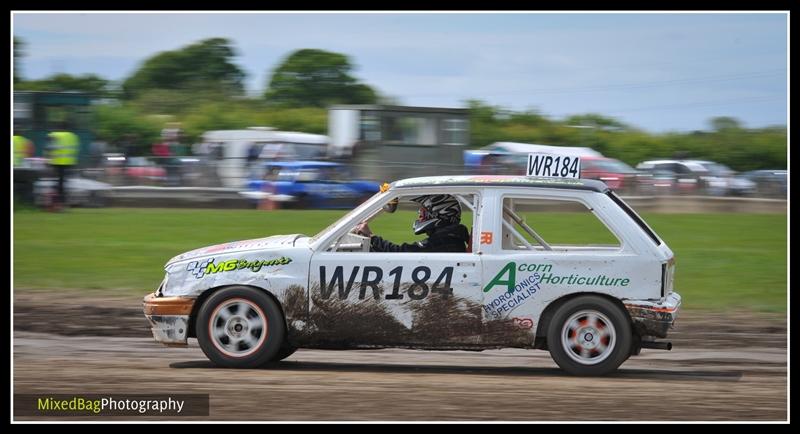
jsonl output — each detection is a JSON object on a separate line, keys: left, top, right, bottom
{"left": 196, "top": 287, "right": 286, "bottom": 368}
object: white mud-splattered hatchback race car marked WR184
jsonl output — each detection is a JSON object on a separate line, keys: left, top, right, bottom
{"left": 144, "top": 168, "right": 681, "bottom": 375}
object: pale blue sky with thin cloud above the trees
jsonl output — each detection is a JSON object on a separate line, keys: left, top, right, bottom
{"left": 13, "top": 13, "right": 788, "bottom": 132}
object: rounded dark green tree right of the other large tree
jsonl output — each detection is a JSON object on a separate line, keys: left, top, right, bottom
{"left": 264, "top": 49, "right": 377, "bottom": 107}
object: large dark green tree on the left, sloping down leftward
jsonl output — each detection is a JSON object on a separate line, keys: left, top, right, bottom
{"left": 122, "top": 38, "right": 245, "bottom": 98}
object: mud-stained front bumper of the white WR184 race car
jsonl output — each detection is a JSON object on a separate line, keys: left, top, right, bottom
{"left": 143, "top": 293, "right": 195, "bottom": 347}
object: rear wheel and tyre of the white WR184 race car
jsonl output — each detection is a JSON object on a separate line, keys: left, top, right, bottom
{"left": 547, "top": 295, "right": 633, "bottom": 376}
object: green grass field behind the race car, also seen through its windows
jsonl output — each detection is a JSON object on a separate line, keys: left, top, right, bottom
{"left": 14, "top": 208, "right": 787, "bottom": 312}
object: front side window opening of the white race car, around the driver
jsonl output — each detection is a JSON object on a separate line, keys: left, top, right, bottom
{"left": 330, "top": 194, "right": 477, "bottom": 253}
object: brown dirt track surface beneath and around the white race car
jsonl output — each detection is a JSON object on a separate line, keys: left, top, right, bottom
{"left": 14, "top": 293, "right": 788, "bottom": 421}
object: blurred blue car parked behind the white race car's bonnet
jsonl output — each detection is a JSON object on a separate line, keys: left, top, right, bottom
{"left": 242, "top": 161, "right": 380, "bottom": 209}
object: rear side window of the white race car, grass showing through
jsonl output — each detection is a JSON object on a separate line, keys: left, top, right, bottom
{"left": 502, "top": 196, "right": 621, "bottom": 251}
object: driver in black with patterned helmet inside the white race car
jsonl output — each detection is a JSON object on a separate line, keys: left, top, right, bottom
{"left": 354, "top": 194, "right": 469, "bottom": 253}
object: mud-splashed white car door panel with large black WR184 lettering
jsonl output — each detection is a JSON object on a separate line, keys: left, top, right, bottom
{"left": 308, "top": 193, "right": 483, "bottom": 348}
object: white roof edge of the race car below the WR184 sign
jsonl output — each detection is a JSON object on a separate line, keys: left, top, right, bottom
{"left": 391, "top": 175, "right": 608, "bottom": 193}
